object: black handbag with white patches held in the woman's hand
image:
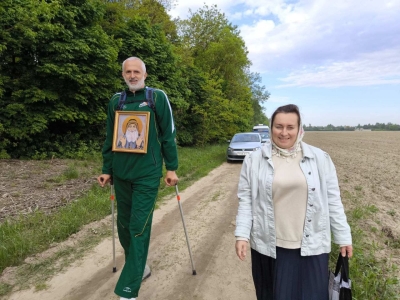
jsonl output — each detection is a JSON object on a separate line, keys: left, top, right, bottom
{"left": 329, "top": 253, "right": 352, "bottom": 300}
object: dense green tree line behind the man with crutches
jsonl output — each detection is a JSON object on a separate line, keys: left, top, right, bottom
{"left": 0, "top": 0, "right": 269, "bottom": 158}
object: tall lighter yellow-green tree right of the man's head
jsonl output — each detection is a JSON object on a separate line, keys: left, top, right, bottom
{"left": 174, "top": 5, "right": 266, "bottom": 145}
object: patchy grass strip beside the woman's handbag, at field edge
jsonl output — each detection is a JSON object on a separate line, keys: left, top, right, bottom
{"left": 330, "top": 190, "right": 400, "bottom": 300}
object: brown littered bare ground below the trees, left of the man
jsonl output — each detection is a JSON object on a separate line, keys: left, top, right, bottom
{"left": 0, "top": 159, "right": 99, "bottom": 222}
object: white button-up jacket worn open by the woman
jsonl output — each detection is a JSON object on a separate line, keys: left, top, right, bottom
{"left": 235, "top": 142, "right": 352, "bottom": 258}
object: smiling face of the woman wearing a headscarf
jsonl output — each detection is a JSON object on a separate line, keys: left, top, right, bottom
{"left": 272, "top": 113, "right": 299, "bottom": 149}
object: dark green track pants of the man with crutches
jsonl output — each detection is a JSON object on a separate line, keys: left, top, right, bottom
{"left": 114, "top": 177, "right": 160, "bottom": 298}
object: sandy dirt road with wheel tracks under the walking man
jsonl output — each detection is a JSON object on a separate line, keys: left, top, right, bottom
{"left": 8, "top": 163, "right": 256, "bottom": 300}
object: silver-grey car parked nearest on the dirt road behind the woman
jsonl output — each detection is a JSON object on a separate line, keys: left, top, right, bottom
{"left": 226, "top": 132, "right": 262, "bottom": 162}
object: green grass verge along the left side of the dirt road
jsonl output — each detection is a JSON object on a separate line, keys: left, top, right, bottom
{"left": 0, "top": 145, "right": 227, "bottom": 296}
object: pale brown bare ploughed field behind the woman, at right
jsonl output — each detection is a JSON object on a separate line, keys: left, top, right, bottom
{"left": 304, "top": 131, "right": 400, "bottom": 270}
